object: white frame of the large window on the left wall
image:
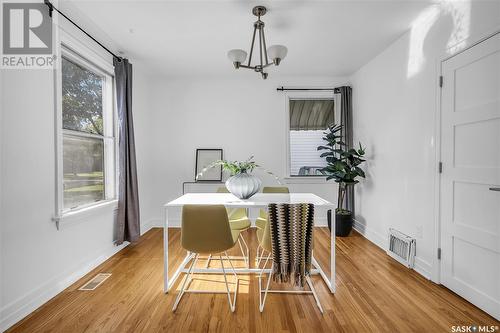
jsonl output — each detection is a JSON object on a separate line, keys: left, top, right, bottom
{"left": 54, "top": 29, "right": 119, "bottom": 218}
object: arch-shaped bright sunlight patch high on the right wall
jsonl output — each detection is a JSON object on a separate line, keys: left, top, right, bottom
{"left": 406, "top": 0, "right": 471, "bottom": 78}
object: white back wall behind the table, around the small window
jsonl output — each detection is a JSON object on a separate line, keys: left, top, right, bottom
{"left": 141, "top": 75, "right": 346, "bottom": 225}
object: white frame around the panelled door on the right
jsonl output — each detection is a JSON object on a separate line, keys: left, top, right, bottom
{"left": 430, "top": 26, "right": 500, "bottom": 284}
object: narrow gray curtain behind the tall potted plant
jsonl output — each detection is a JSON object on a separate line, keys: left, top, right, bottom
{"left": 338, "top": 86, "right": 354, "bottom": 217}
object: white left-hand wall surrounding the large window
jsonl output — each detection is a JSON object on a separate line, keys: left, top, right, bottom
{"left": 0, "top": 24, "right": 154, "bottom": 331}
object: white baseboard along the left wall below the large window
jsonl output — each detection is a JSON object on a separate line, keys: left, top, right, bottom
{"left": 0, "top": 242, "right": 129, "bottom": 332}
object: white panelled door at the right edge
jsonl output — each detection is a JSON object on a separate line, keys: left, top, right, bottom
{"left": 441, "top": 34, "right": 500, "bottom": 319}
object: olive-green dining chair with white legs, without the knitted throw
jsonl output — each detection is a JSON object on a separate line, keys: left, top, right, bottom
{"left": 172, "top": 205, "right": 240, "bottom": 312}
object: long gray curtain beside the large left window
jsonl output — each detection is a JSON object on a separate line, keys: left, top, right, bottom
{"left": 113, "top": 58, "right": 140, "bottom": 244}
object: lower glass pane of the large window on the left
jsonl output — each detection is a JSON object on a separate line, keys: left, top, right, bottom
{"left": 63, "top": 135, "right": 105, "bottom": 209}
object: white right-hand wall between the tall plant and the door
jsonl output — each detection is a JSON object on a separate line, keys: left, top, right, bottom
{"left": 351, "top": 1, "right": 500, "bottom": 280}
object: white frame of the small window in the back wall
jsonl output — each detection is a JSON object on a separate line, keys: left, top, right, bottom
{"left": 284, "top": 91, "right": 340, "bottom": 180}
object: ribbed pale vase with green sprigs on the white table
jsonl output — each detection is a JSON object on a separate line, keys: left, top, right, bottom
{"left": 196, "top": 156, "right": 281, "bottom": 199}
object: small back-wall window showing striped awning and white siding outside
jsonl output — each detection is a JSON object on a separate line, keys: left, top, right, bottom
{"left": 288, "top": 97, "right": 335, "bottom": 177}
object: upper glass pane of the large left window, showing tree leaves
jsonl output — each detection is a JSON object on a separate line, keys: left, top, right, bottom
{"left": 62, "top": 57, "right": 103, "bottom": 135}
